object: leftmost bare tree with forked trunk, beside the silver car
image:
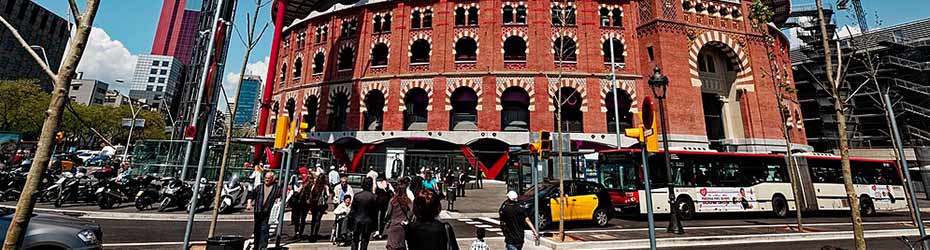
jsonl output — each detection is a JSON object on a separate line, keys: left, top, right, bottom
{"left": 0, "top": 0, "right": 100, "bottom": 249}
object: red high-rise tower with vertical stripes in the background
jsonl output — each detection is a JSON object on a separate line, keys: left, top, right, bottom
{"left": 152, "top": 0, "right": 200, "bottom": 65}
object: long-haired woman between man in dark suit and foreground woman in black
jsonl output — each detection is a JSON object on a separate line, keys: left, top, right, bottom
{"left": 385, "top": 177, "right": 413, "bottom": 250}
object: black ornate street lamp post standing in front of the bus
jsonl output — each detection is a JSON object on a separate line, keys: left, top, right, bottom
{"left": 649, "top": 67, "right": 685, "bottom": 234}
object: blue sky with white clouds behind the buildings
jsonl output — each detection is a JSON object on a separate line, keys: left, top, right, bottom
{"left": 29, "top": 0, "right": 930, "bottom": 96}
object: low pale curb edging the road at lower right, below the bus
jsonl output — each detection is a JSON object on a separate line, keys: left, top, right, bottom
{"left": 526, "top": 229, "right": 918, "bottom": 250}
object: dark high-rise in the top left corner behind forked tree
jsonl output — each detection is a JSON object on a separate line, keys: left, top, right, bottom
{"left": 0, "top": 0, "right": 70, "bottom": 91}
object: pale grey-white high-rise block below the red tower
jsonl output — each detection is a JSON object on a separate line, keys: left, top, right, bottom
{"left": 129, "top": 55, "right": 183, "bottom": 109}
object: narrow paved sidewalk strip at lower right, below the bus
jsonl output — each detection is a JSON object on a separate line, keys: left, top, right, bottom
{"left": 526, "top": 222, "right": 918, "bottom": 249}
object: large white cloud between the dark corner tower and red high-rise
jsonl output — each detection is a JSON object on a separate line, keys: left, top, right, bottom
{"left": 77, "top": 27, "right": 138, "bottom": 95}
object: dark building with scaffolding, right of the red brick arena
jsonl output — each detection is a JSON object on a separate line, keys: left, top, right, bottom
{"left": 788, "top": 6, "right": 930, "bottom": 156}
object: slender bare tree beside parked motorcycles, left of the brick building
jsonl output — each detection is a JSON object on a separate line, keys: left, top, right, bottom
{"left": 207, "top": 0, "right": 271, "bottom": 238}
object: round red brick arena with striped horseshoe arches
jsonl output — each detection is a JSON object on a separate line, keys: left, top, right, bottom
{"left": 260, "top": 0, "right": 809, "bottom": 178}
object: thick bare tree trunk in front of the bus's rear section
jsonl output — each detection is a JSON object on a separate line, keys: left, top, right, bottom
{"left": 816, "top": 0, "right": 866, "bottom": 250}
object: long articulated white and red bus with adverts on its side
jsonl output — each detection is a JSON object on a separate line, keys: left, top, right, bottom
{"left": 597, "top": 149, "right": 907, "bottom": 219}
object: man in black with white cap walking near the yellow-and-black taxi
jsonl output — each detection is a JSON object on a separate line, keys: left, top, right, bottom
{"left": 498, "top": 191, "right": 539, "bottom": 250}
